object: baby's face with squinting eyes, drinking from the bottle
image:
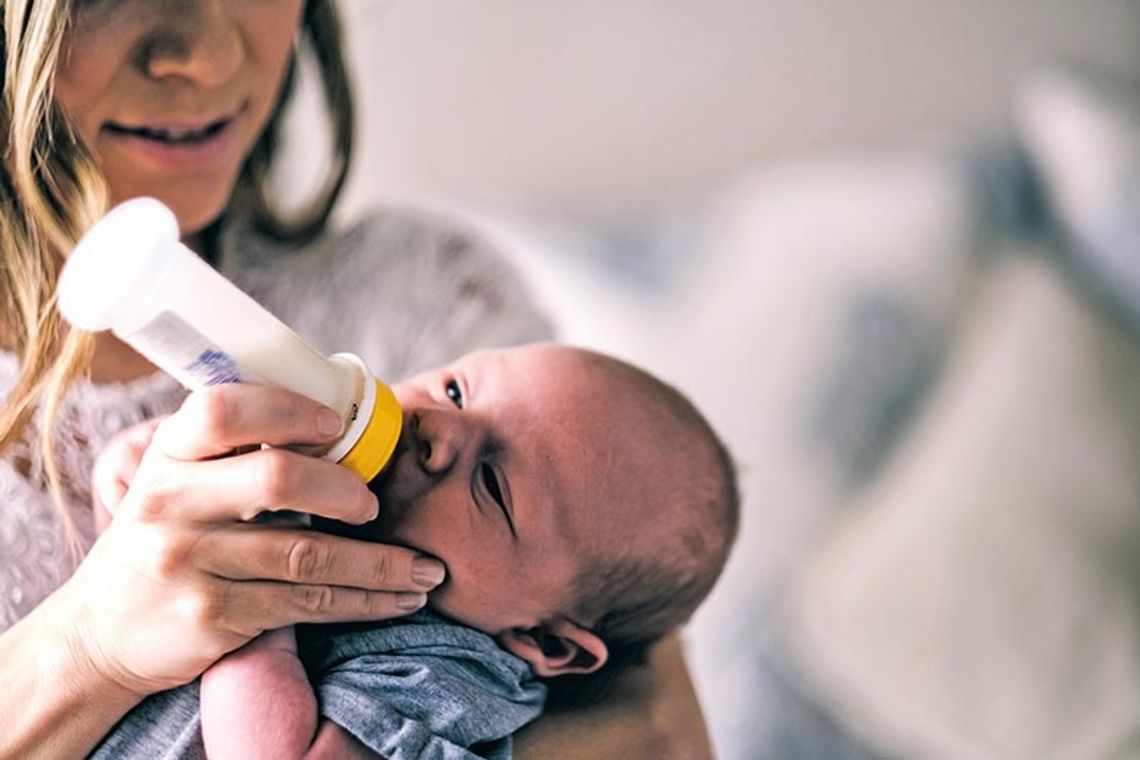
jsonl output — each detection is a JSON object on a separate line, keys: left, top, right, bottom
{"left": 368, "top": 345, "right": 656, "bottom": 634}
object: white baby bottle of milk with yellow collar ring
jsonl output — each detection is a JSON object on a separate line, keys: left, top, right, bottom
{"left": 57, "top": 198, "right": 402, "bottom": 481}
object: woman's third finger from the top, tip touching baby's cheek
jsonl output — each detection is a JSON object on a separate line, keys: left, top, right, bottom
{"left": 195, "top": 525, "right": 445, "bottom": 593}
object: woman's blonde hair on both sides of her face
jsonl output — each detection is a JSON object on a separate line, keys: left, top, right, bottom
{"left": 0, "top": 0, "right": 353, "bottom": 535}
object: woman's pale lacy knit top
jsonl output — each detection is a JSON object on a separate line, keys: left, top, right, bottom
{"left": 0, "top": 211, "right": 551, "bottom": 630}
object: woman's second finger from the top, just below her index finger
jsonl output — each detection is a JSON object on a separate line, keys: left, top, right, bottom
{"left": 123, "top": 449, "right": 378, "bottom": 523}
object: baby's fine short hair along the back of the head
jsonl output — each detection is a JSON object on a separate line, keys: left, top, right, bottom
{"left": 563, "top": 354, "right": 740, "bottom": 664}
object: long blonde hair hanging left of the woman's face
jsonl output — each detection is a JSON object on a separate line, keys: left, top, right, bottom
{"left": 0, "top": 0, "right": 107, "bottom": 549}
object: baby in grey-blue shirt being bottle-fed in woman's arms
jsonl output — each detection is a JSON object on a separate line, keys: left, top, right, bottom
{"left": 96, "top": 344, "right": 739, "bottom": 759}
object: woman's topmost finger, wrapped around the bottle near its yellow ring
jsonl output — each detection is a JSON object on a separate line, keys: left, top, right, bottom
{"left": 154, "top": 383, "right": 343, "bottom": 460}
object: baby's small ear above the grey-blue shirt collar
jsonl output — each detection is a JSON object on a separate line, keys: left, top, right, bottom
{"left": 496, "top": 618, "right": 609, "bottom": 678}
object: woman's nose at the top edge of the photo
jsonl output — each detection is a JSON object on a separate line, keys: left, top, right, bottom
{"left": 141, "top": 0, "right": 246, "bottom": 87}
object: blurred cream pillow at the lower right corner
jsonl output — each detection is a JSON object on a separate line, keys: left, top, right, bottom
{"left": 784, "top": 252, "right": 1140, "bottom": 760}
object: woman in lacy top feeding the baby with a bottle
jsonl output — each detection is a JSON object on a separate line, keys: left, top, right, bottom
{"left": 0, "top": 0, "right": 707, "bottom": 757}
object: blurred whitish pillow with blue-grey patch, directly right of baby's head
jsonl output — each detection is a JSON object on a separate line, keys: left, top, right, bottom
{"left": 674, "top": 150, "right": 978, "bottom": 758}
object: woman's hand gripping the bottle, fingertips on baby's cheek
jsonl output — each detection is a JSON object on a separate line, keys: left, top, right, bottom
{"left": 61, "top": 385, "right": 442, "bottom": 694}
